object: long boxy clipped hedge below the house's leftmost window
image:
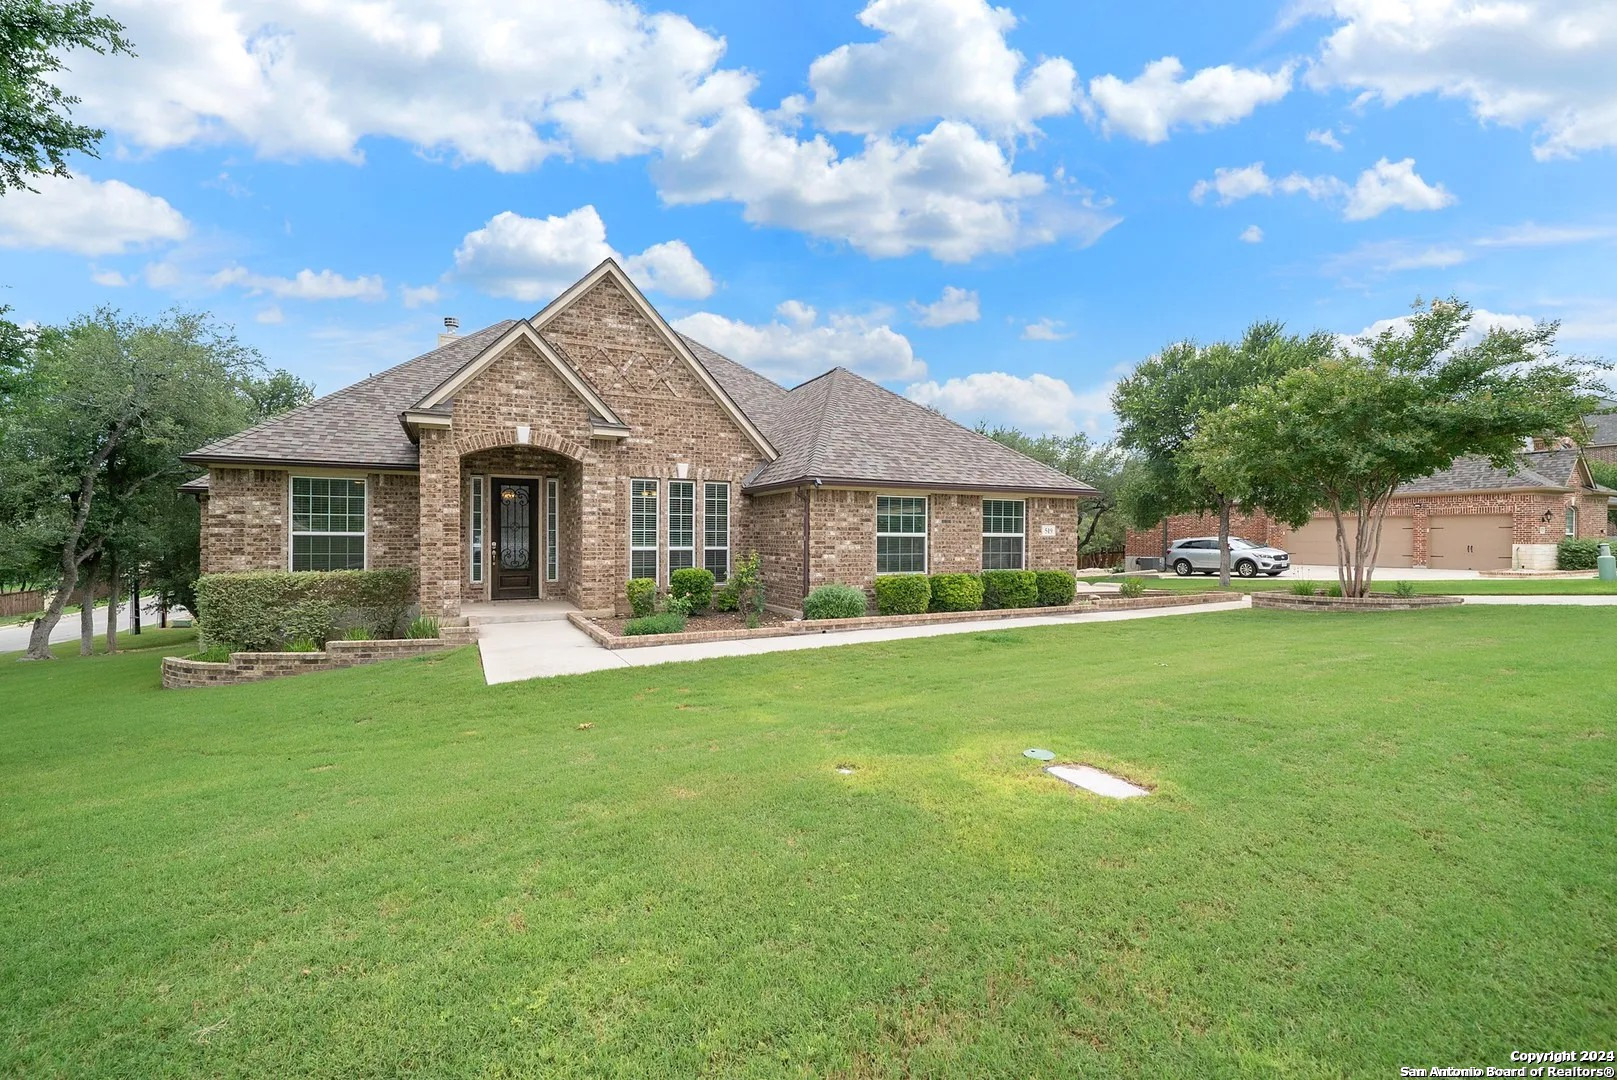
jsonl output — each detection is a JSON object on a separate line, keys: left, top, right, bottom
{"left": 197, "top": 569, "right": 416, "bottom": 653}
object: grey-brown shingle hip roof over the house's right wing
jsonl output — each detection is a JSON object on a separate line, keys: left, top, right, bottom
{"left": 745, "top": 367, "right": 1095, "bottom": 496}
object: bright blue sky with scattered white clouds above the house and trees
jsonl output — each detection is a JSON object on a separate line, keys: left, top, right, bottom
{"left": 0, "top": 0, "right": 1617, "bottom": 435}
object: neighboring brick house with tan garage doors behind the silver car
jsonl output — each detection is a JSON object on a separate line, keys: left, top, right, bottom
{"left": 1125, "top": 449, "right": 1614, "bottom": 571}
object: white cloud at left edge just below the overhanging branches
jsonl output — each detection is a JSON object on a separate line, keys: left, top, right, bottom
{"left": 0, "top": 176, "right": 191, "bottom": 255}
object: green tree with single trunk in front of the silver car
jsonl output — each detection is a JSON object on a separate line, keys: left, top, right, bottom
{"left": 1112, "top": 322, "right": 1332, "bottom": 589}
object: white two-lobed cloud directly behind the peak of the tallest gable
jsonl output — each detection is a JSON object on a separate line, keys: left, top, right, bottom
{"left": 454, "top": 204, "right": 713, "bottom": 302}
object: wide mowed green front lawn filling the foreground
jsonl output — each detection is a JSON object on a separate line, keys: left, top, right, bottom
{"left": 0, "top": 608, "right": 1617, "bottom": 1077}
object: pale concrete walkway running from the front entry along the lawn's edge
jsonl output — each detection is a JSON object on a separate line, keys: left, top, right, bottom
{"left": 477, "top": 597, "right": 1250, "bottom": 684}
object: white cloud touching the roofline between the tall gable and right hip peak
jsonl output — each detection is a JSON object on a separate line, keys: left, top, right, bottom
{"left": 674, "top": 301, "right": 927, "bottom": 386}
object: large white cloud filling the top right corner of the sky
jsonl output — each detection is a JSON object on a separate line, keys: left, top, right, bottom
{"left": 1307, "top": 0, "right": 1617, "bottom": 158}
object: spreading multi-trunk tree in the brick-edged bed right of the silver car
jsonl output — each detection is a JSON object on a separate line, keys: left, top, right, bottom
{"left": 1187, "top": 299, "right": 1596, "bottom": 597}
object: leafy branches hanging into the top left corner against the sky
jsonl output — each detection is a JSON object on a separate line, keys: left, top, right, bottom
{"left": 0, "top": 0, "right": 133, "bottom": 196}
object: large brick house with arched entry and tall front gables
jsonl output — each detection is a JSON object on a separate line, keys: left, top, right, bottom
{"left": 184, "top": 260, "right": 1095, "bottom": 616}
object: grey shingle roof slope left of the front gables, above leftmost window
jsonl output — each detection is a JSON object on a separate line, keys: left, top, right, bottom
{"left": 184, "top": 319, "right": 514, "bottom": 469}
